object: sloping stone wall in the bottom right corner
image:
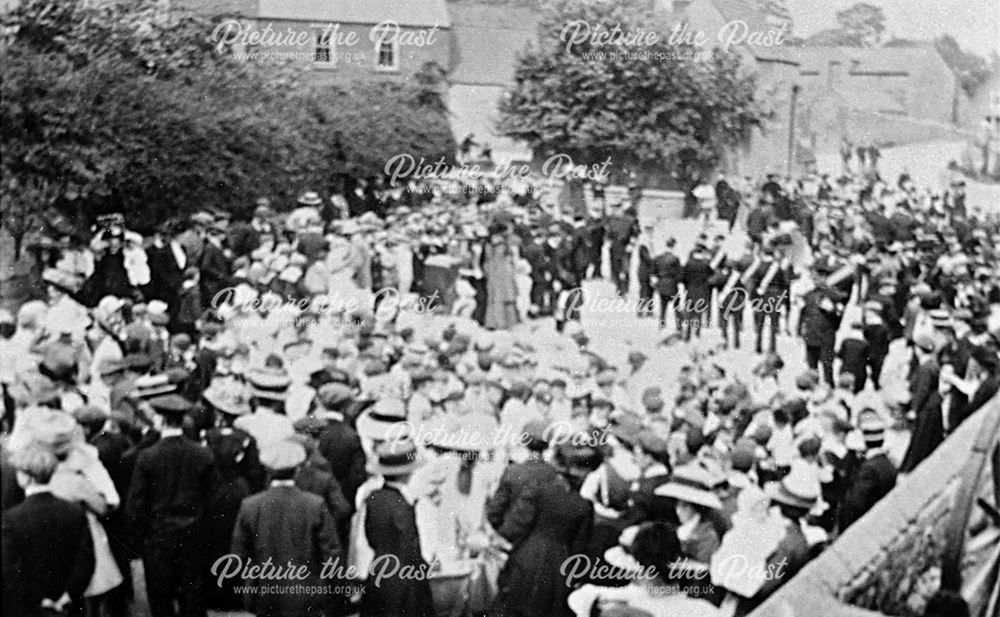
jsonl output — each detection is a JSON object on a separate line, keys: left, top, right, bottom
{"left": 751, "top": 397, "right": 1000, "bottom": 617}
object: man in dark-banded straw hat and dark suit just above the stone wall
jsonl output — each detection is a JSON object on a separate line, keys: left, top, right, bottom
{"left": 840, "top": 409, "right": 897, "bottom": 531}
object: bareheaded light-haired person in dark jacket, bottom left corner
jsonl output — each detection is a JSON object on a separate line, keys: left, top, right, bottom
{"left": 2, "top": 447, "right": 94, "bottom": 617}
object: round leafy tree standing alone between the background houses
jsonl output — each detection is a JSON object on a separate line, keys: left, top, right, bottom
{"left": 499, "top": 0, "right": 763, "bottom": 186}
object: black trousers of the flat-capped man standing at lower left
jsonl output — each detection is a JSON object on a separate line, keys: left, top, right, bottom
{"left": 142, "top": 533, "right": 206, "bottom": 617}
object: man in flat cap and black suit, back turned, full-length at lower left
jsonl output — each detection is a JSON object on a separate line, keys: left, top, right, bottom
{"left": 126, "top": 394, "right": 218, "bottom": 617}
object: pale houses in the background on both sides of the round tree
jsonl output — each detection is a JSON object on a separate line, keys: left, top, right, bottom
{"left": 171, "top": 0, "right": 997, "bottom": 174}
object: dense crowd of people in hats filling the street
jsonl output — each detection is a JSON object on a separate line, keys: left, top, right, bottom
{"left": 0, "top": 166, "right": 1000, "bottom": 617}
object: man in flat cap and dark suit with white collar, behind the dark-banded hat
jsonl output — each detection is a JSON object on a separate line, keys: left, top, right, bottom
{"left": 314, "top": 383, "right": 368, "bottom": 546}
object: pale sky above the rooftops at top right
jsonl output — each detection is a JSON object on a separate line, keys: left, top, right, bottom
{"left": 786, "top": 0, "right": 1000, "bottom": 55}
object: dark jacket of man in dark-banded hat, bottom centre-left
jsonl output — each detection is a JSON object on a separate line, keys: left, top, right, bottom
{"left": 361, "top": 485, "right": 435, "bottom": 617}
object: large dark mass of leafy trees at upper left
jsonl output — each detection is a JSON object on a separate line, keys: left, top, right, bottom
{"left": 0, "top": 0, "right": 455, "bottom": 248}
